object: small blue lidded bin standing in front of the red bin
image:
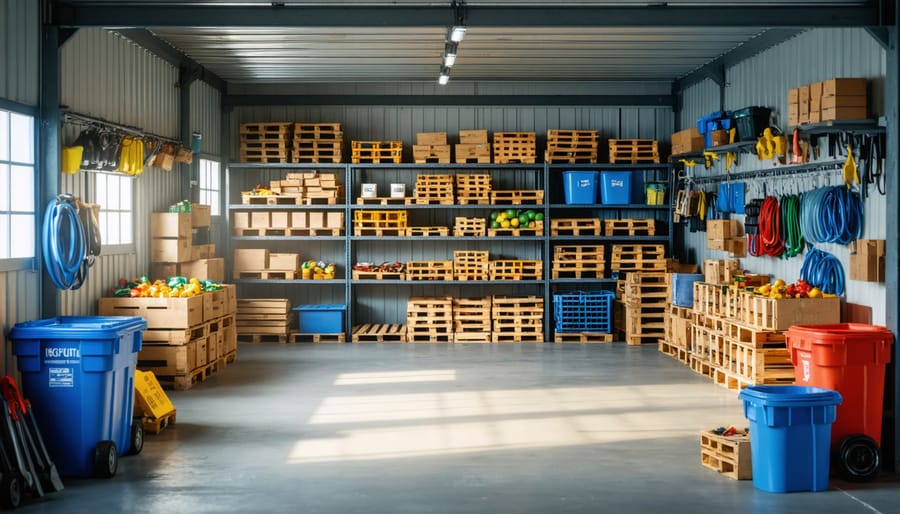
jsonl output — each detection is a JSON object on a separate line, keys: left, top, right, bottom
{"left": 740, "top": 386, "right": 841, "bottom": 493}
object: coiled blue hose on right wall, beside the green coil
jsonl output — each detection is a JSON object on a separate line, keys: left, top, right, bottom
{"left": 800, "top": 186, "right": 865, "bottom": 244}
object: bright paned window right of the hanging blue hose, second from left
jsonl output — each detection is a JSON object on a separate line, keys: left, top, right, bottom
{"left": 94, "top": 173, "right": 134, "bottom": 246}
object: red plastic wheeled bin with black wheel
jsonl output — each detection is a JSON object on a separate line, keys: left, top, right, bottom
{"left": 786, "top": 323, "right": 894, "bottom": 481}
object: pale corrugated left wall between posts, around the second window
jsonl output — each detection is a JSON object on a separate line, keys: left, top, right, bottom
{"left": 60, "top": 29, "right": 188, "bottom": 315}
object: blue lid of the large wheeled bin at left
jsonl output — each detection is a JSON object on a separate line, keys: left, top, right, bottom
{"left": 9, "top": 316, "right": 147, "bottom": 339}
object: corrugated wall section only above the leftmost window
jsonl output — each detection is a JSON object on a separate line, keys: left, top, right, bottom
{"left": 0, "top": 0, "right": 41, "bottom": 105}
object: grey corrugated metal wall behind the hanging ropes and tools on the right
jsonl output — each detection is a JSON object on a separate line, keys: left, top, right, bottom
{"left": 680, "top": 29, "right": 887, "bottom": 324}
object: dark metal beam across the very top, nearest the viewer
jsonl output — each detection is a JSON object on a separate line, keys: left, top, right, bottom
{"left": 53, "top": 1, "right": 881, "bottom": 29}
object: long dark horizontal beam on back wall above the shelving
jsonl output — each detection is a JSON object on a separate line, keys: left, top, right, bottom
{"left": 223, "top": 95, "right": 675, "bottom": 108}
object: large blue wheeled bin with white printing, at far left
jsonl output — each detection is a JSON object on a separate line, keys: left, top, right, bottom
{"left": 9, "top": 316, "right": 147, "bottom": 477}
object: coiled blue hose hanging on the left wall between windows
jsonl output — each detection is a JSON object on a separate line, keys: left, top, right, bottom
{"left": 41, "top": 195, "right": 87, "bottom": 289}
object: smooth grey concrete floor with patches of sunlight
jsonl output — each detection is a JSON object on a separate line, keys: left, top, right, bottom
{"left": 23, "top": 343, "right": 900, "bottom": 514}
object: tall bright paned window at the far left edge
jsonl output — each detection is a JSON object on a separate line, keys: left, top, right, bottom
{"left": 0, "top": 109, "right": 37, "bottom": 259}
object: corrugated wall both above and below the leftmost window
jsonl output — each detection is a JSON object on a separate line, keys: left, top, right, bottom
{"left": 0, "top": 0, "right": 41, "bottom": 373}
